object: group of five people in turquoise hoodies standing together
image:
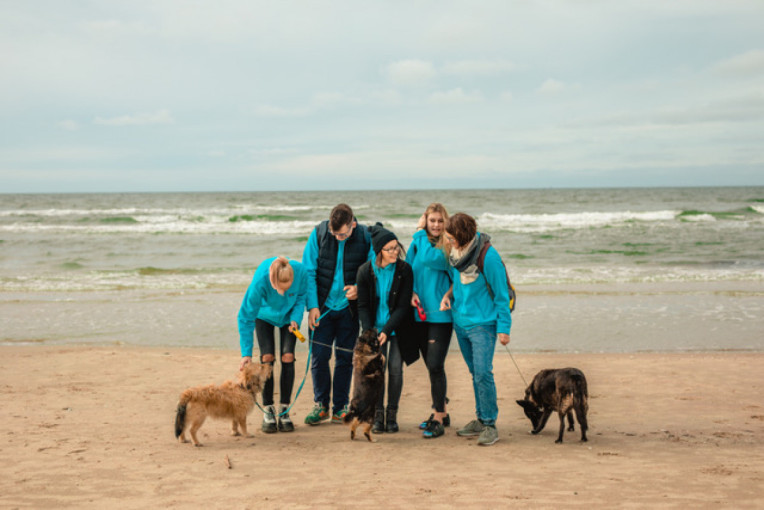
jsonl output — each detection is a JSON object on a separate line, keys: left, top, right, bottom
{"left": 238, "top": 203, "right": 512, "bottom": 445}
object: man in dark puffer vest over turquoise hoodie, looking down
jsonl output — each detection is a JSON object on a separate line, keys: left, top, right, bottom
{"left": 302, "top": 204, "right": 374, "bottom": 425}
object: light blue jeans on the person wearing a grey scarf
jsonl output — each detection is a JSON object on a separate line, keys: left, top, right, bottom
{"left": 454, "top": 323, "right": 499, "bottom": 426}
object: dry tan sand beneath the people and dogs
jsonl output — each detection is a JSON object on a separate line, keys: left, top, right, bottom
{"left": 0, "top": 346, "right": 764, "bottom": 508}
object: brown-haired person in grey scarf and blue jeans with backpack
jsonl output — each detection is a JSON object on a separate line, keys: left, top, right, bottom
{"left": 441, "top": 213, "right": 512, "bottom": 446}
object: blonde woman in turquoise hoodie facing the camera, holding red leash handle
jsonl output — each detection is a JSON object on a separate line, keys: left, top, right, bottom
{"left": 406, "top": 203, "right": 453, "bottom": 438}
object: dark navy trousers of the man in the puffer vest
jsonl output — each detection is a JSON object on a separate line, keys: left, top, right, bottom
{"left": 310, "top": 306, "right": 360, "bottom": 413}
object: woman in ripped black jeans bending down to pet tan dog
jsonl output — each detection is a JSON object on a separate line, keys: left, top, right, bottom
{"left": 238, "top": 257, "right": 308, "bottom": 434}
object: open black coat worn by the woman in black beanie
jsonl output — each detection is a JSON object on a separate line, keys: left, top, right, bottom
{"left": 356, "top": 260, "right": 419, "bottom": 365}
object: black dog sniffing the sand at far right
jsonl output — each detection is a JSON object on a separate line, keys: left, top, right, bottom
{"left": 517, "top": 368, "right": 589, "bottom": 443}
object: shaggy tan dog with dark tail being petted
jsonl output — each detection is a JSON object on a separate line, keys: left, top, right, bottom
{"left": 175, "top": 363, "right": 273, "bottom": 446}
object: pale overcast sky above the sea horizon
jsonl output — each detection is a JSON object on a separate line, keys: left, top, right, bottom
{"left": 0, "top": 0, "right": 764, "bottom": 193}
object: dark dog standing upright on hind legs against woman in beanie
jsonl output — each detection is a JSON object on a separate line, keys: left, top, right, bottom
{"left": 345, "top": 329, "right": 385, "bottom": 443}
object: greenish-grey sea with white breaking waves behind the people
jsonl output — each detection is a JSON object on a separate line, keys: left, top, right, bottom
{"left": 0, "top": 187, "right": 764, "bottom": 350}
